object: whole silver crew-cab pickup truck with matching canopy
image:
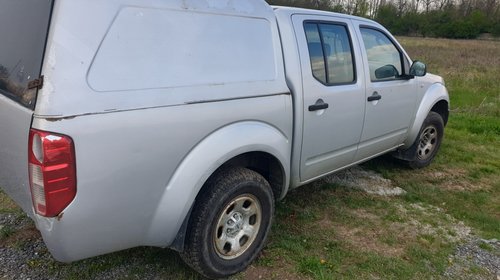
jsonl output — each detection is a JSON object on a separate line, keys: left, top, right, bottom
{"left": 0, "top": 0, "right": 449, "bottom": 278}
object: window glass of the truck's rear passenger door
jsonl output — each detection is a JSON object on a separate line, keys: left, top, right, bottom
{"left": 304, "top": 23, "right": 356, "bottom": 85}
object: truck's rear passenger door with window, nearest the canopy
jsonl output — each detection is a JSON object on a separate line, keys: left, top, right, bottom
{"left": 293, "top": 15, "right": 365, "bottom": 182}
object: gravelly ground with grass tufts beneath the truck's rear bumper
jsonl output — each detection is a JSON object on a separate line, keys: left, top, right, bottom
{"left": 0, "top": 212, "right": 194, "bottom": 280}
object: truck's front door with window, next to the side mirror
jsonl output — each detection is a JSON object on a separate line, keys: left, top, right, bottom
{"left": 355, "top": 25, "right": 417, "bottom": 161}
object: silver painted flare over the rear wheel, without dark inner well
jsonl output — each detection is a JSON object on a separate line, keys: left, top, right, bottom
{"left": 146, "top": 121, "right": 291, "bottom": 247}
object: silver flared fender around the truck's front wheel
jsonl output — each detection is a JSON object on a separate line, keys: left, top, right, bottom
{"left": 403, "top": 83, "right": 450, "bottom": 148}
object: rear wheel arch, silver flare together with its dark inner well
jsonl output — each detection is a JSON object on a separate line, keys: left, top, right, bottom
{"left": 146, "top": 121, "right": 291, "bottom": 250}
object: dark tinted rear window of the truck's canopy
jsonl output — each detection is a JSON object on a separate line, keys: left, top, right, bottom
{"left": 0, "top": 0, "right": 53, "bottom": 109}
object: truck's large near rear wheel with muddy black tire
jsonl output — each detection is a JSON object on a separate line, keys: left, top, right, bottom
{"left": 181, "top": 167, "right": 274, "bottom": 278}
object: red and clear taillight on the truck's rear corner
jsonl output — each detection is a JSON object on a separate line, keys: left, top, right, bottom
{"left": 28, "top": 129, "right": 76, "bottom": 217}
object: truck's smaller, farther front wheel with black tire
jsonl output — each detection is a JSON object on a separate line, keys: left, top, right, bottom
{"left": 408, "top": 112, "right": 444, "bottom": 169}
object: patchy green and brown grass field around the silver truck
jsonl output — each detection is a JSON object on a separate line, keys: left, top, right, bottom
{"left": 0, "top": 38, "right": 500, "bottom": 279}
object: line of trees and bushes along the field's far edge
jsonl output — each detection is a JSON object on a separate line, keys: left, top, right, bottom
{"left": 266, "top": 0, "right": 500, "bottom": 39}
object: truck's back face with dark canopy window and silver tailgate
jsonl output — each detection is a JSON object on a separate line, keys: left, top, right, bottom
{"left": 0, "top": 0, "right": 53, "bottom": 213}
